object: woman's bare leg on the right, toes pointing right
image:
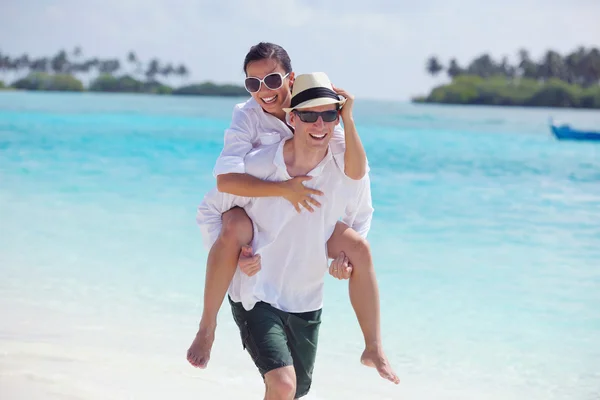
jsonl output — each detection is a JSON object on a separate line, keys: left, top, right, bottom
{"left": 327, "top": 222, "right": 400, "bottom": 384}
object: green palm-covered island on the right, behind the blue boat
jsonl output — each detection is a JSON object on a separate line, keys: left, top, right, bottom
{"left": 412, "top": 47, "right": 600, "bottom": 109}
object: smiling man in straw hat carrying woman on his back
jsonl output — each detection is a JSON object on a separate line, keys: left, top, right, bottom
{"left": 198, "top": 73, "right": 394, "bottom": 400}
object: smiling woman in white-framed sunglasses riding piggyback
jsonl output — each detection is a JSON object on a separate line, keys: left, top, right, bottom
{"left": 187, "top": 43, "right": 399, "bottom": 383}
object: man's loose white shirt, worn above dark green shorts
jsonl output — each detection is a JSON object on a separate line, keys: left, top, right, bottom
{"left": 197, "top": 139, "right": 373, "bottom": 312}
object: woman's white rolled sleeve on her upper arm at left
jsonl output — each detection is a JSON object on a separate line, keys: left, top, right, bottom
{"left": 213, "top": 108, "right": 252, "bottom": 177}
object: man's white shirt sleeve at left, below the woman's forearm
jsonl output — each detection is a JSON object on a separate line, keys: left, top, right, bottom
{"left": 196, "top": 188, "right": 251, "bottom": 249}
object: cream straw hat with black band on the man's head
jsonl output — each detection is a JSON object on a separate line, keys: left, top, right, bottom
{"left": 283, "top": 72, "right": 346, "bottom": 113}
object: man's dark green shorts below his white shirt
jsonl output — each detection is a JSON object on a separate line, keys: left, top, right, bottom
{"left": 229, "top": 298, "right": 321, "bottom": 398}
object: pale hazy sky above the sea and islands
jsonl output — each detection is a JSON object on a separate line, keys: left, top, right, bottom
{"left": 0, "top": 0, "right": 600, "bottom": 100}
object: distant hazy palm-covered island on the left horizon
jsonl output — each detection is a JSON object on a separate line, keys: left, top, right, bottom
{"left": 0, "top": 47, "right": 248, "bottom": 96}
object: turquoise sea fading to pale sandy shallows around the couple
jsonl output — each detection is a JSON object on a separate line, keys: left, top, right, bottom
{"left": 0, "top": 92, "right": 600, "bottom": 400}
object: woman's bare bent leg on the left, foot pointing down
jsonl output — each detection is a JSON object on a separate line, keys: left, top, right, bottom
{"left": 187, "top": 207, "right": 253, "bottom": 368}
